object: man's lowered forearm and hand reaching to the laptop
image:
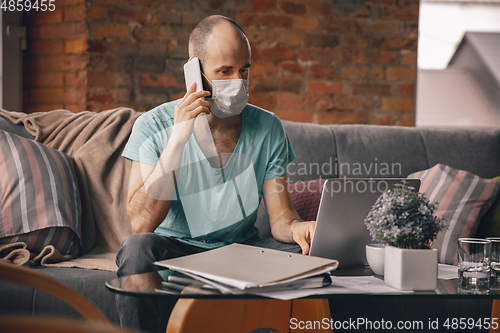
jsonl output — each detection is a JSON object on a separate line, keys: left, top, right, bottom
{"left": 262, "top": 173, "right": 316, "bottom": 254}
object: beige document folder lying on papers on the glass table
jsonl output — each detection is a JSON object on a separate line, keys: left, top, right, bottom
{"left": 155, "top": 244, "right": 338, "bottom": 290}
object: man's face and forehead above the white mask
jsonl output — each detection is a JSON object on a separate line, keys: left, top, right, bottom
{"left": 202, "top": 23, "right": 251, "bottom": 91}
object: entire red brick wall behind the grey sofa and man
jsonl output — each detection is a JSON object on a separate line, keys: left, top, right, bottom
{"left": 21, "top": 0, "right": 419, "bottom": 125}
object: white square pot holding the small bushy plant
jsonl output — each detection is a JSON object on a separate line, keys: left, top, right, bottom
{"left": 384, "top": 246, "right": 438, "bottom": 291}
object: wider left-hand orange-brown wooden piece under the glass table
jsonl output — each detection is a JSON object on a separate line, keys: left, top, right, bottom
{"left": 167, "top": 298, "right": 292, "bottom": 333}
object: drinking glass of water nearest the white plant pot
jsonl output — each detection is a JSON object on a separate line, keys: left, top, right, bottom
{"left": 458, "top": 238, "right": 491, "bottom": 294}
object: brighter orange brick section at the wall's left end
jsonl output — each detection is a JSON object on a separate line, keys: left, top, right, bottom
{"left": 23, "top": 0, "right": 89, "bottom": 112}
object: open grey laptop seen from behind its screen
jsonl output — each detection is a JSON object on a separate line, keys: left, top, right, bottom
{"left": 309, "top": 178, "right": 420, "bottom": 271}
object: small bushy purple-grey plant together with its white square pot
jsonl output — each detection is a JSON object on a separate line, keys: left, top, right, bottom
{"left": 365, "top": 184, "right": 445, "bottom": 290}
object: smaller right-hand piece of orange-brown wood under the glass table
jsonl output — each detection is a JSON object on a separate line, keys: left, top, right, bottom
{"left": 290, "top": 299, "right": 333, "bottom": 333}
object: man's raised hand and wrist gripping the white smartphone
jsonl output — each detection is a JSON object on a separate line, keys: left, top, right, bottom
{"left": 171, "top": 83, "right": 212, "bottom": 145}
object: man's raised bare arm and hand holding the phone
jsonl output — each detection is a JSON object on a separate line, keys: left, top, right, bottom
{"left": 126, "top": 84, "right": 211, "bottom": 233}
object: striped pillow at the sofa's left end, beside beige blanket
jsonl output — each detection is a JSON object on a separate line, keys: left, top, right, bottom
{"left": 0, "top": 130, "right": 81, "bottom": 256}
